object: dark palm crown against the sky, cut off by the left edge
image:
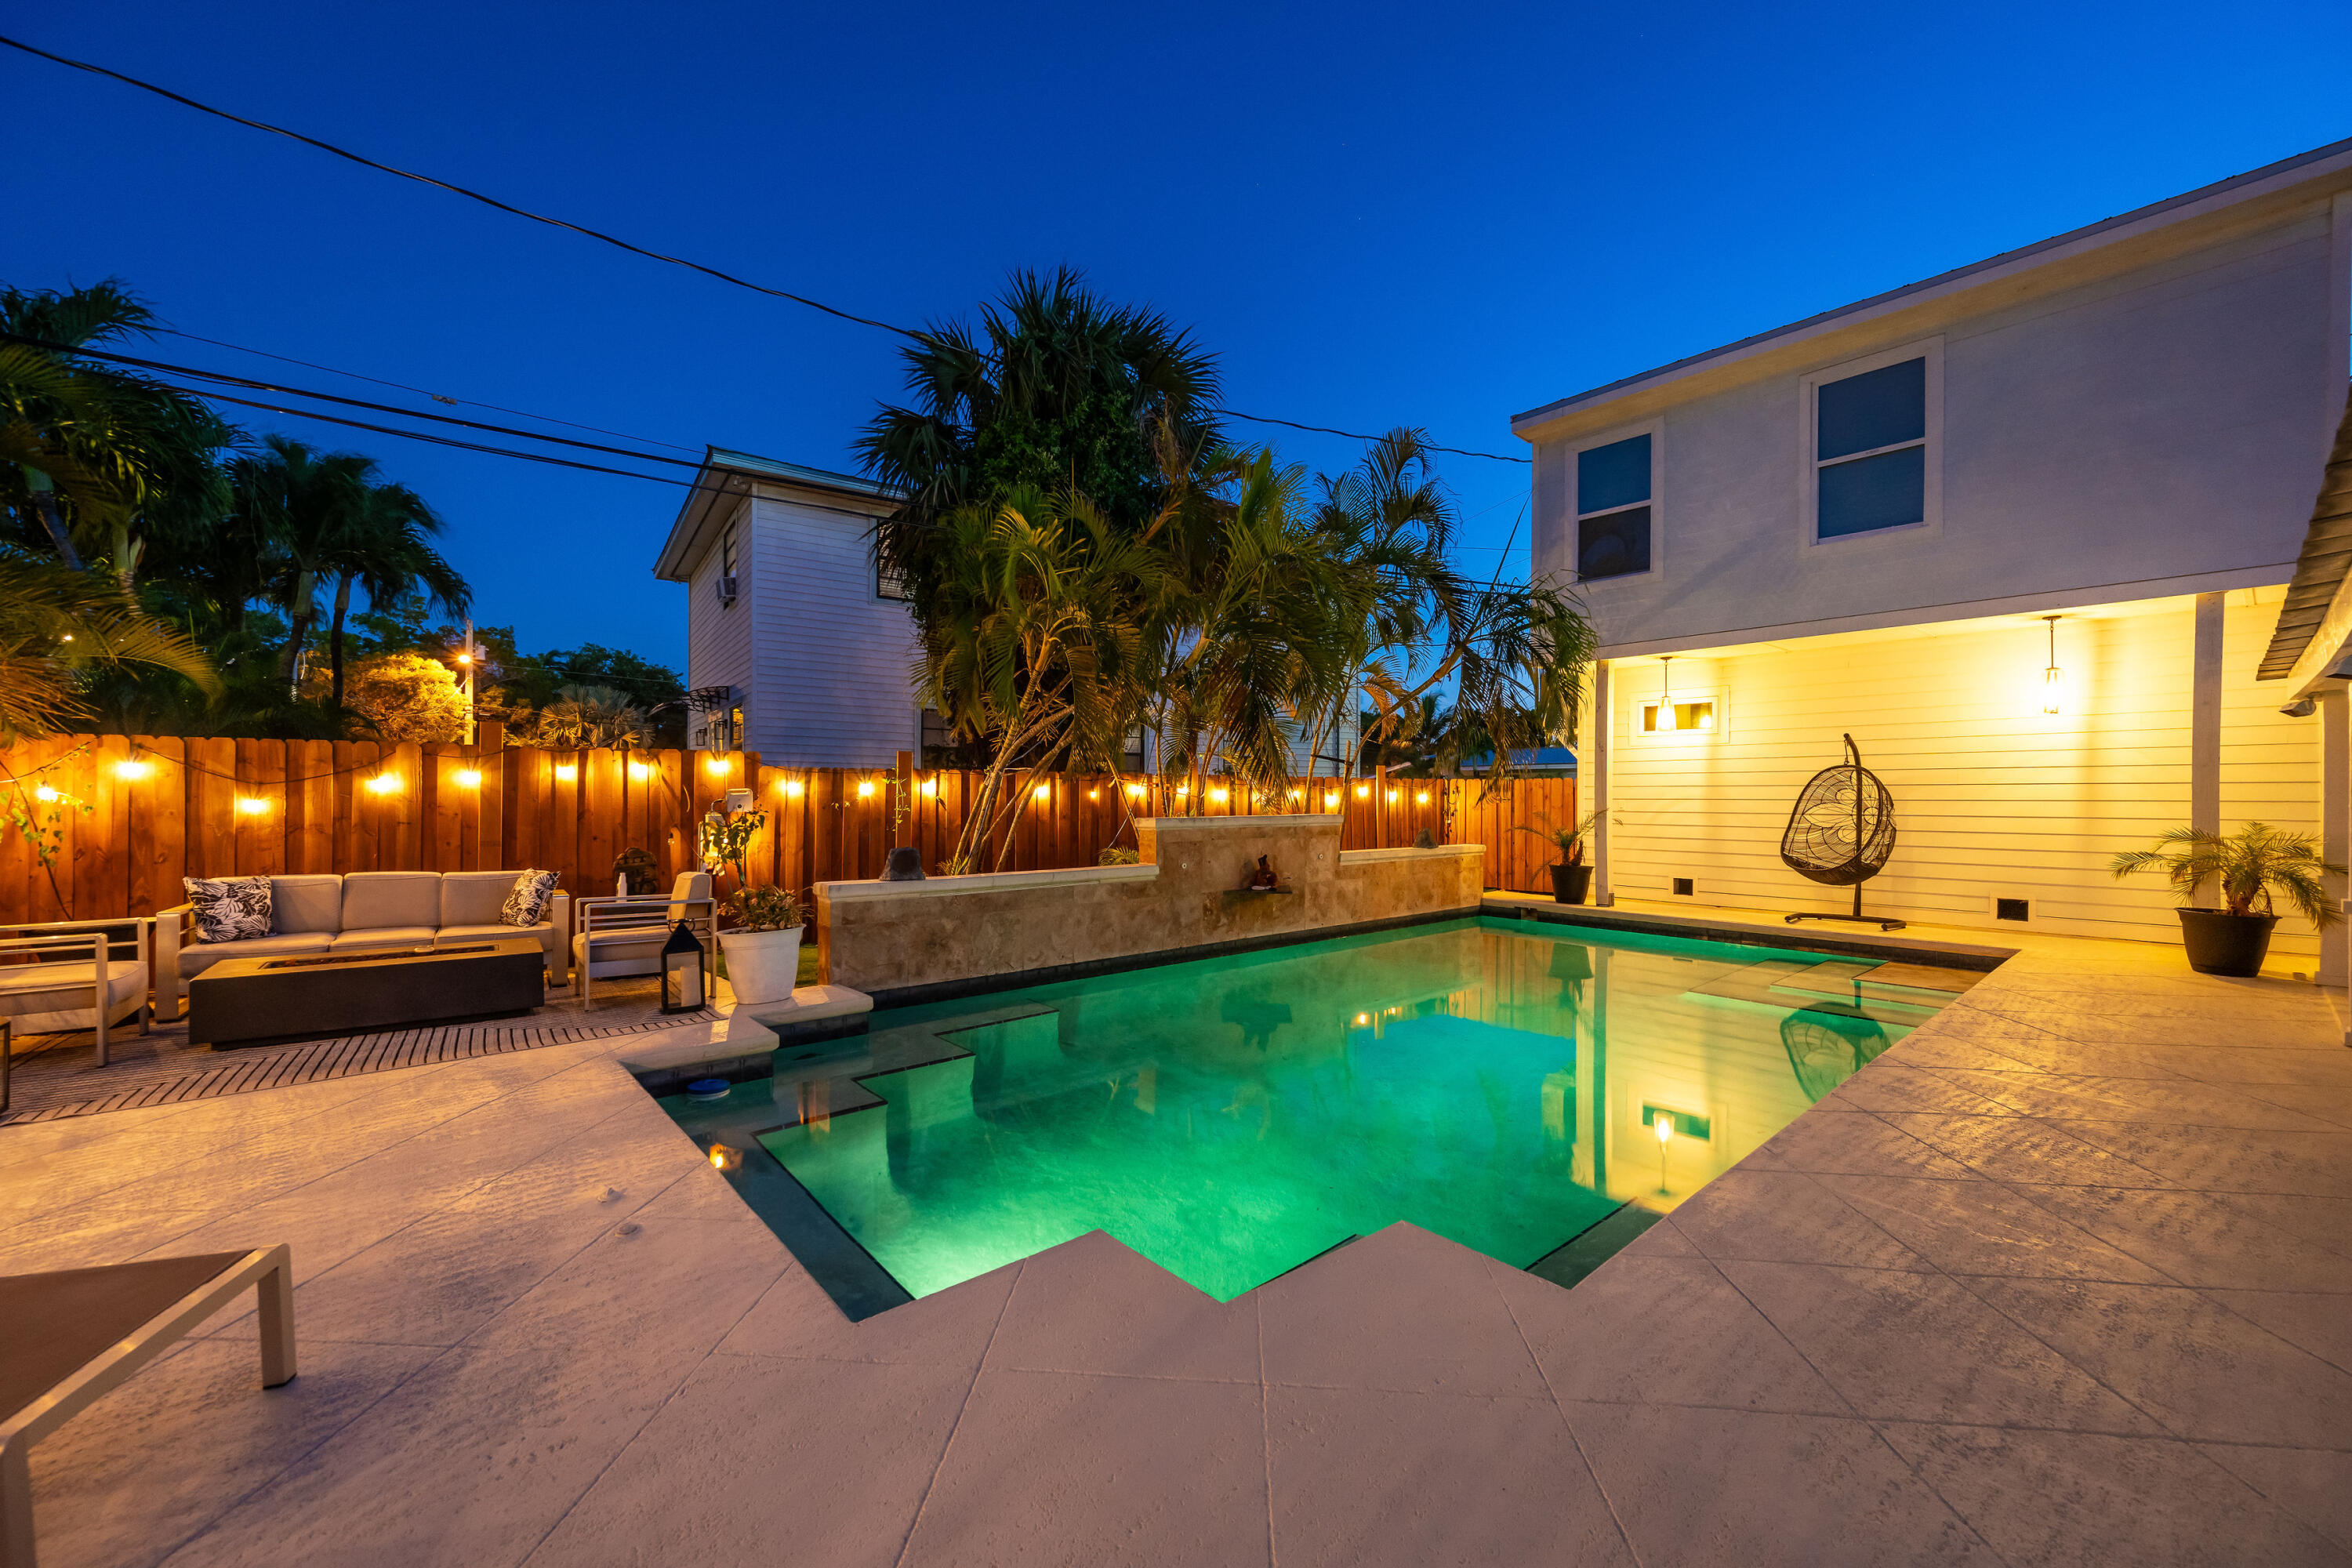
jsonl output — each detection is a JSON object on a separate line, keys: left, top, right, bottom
{"left": 0, "top": 278, "right": 235, "bottom": 593}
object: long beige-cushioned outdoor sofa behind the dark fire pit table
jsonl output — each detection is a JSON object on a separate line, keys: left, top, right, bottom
{"left": 155, "top": 872, "right": 572, "bottom": 1018}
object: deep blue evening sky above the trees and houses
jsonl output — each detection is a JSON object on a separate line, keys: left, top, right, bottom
{"left": 0, "top": 0, "right": 2352, "bottom": 666}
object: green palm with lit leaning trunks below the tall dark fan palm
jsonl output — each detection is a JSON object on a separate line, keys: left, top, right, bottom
{"left": 920, "top": 489, "right": 1164, "bottom": 874}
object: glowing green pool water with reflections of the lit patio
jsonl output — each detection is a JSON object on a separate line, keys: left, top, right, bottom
{"left": 734, "top": 916, "right": 1947, "bottom": 1300}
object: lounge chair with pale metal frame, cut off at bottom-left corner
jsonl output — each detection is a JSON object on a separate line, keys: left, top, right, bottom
{"left": 0, "top": 1243, "right": 294, "bottom": 1568}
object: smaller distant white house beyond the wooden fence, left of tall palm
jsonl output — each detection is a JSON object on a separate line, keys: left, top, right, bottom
{"left": 654, "top": 447, "right": 922, "bottom": 767}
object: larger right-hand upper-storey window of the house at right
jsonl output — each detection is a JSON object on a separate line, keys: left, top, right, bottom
{"left": 1811, "top": 355, "right": 1929, "bottom": 539}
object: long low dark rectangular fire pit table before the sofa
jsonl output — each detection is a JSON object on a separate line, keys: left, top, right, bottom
{"left": 188, "top": 935, "right": 548, "bottom": 1048}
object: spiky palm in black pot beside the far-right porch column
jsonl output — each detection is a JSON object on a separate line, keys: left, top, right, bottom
{"left": 2107, "top": 822, "right": 2345, "bottom": 975}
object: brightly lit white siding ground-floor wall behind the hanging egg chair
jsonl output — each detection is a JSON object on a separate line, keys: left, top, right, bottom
{"left": 1609, "top": 590, "right": 2319, "bottom": 954}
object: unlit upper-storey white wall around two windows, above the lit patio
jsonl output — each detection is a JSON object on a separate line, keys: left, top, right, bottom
{"left": 1534, "top": 209, "right": 2345, "bottom": 652}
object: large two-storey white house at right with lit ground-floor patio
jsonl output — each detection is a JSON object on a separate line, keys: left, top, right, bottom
{"left": 1512, "top": 141, "right": 2352, "bottom": 982}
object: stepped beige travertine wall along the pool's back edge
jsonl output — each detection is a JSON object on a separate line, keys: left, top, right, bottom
{"left": 816, "top": 815, "right": 1484, "bottom": 992}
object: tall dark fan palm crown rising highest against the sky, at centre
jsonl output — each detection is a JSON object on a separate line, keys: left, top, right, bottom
{"left": 858, "top": 268, "right": 1218, "bottom": 621}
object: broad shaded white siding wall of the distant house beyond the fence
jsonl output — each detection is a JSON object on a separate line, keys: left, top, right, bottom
{"left": 741, "top": 496, "right": 922, "bottom": 767}
